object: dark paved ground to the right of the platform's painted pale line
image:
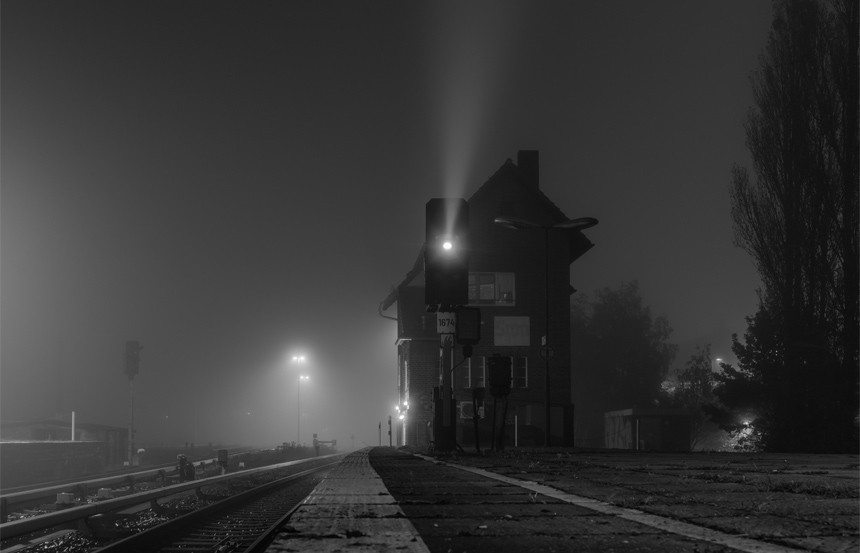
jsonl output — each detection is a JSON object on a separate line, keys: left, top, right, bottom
{"left": 400, "top": 450, "right": 860, "bottom": 552}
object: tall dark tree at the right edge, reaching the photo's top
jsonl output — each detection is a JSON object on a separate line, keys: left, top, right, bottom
{"left": 718, "top": 0, "right": 860, "bottom": 451}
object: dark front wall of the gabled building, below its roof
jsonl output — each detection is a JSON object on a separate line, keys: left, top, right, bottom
{"left": 398, "top": 158, "right": 587, "bottom": 446}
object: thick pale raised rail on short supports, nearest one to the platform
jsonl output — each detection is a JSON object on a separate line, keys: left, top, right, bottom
{"left": 0, "top": 453, "right": 346, "bottom": 539}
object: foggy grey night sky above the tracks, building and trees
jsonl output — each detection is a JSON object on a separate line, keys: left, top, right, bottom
{"left": 5, "top": 0, "right": 771, "bottom": 447}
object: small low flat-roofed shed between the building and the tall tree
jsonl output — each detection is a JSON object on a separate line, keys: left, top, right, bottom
{"left": 603, "top": 408, "right": 690, "bottom": 451}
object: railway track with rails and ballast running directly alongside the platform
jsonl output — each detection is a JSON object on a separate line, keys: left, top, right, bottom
{"left": 0, "top": 454, "right": 343, "bottom": 553}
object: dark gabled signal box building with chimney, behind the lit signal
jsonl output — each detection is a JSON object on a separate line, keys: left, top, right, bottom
{"left": 380, "top": 151, "right": 593, "bottom": 447}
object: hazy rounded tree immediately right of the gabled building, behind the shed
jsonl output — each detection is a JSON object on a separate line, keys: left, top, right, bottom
{"left": 571, "top": 281, "right": 678, "bottom": 446}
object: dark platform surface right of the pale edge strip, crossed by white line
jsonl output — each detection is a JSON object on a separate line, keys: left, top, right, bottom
{"left": 369, "top": 448, "right": 860, "bottom": 552}
